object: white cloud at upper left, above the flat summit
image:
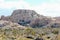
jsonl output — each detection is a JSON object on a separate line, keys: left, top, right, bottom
{"left": 0, "top": 0, "right": 29, "bottom": 9}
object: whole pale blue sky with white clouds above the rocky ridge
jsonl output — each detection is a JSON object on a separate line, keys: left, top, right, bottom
{"left": 0, "top": 0, "right": 60, "bottom": 17}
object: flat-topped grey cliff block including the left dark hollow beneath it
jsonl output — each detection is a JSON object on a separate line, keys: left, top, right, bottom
{"left": 10, "top": 10, "right": 39, "bottom": 26}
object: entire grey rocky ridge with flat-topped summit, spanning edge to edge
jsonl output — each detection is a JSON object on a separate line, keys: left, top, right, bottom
{"left": 1, "top": 9, "right": 60, "bottom": 28}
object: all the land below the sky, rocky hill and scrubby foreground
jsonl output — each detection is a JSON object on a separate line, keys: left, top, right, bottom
{"left": 0, "top": 9, "right": 60, "bottom": 40}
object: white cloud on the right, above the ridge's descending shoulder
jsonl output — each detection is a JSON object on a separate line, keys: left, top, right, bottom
{"left": 32, "top": 3, "right": 60, "bottom": 17}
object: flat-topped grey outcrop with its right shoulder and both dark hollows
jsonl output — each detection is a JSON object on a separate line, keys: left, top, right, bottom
{"left": 10, "top": 10, "right": 51, "bottom": 27}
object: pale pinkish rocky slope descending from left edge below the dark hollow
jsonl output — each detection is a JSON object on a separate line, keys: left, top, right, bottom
{"left": 0, "top": 20, "right": 26, "bottom": 29}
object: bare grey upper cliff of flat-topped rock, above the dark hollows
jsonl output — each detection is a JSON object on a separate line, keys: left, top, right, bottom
{"left": 10, "top": 10, "right": 38, "bottom": 22}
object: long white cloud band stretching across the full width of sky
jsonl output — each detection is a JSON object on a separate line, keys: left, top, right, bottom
{"left": 0, "top": 0, "right": 60, "bottom": 16}
